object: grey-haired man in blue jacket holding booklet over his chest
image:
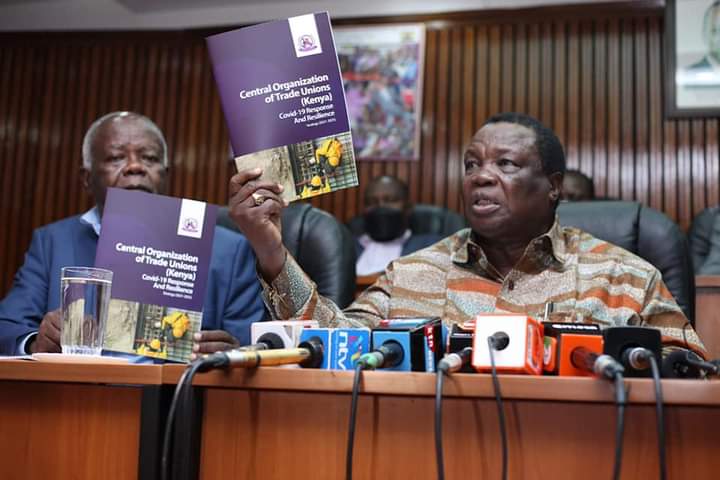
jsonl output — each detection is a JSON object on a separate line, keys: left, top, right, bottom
{"left": 0, "top": 112, "right": 265, "bottom": 355}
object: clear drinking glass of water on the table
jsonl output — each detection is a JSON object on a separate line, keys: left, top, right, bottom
{"left": 60, "top": 267, "right": 112, "bottom": 355}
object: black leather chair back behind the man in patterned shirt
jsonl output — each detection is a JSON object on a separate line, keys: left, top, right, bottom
{"left": 557, "top": 201, "right": 695, "bottom": 324}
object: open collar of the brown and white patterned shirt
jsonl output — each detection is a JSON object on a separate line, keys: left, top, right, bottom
{"left": 450, "top": 215, "right": 567, "bottom": 270}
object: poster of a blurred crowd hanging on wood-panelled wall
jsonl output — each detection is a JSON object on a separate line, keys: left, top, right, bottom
{"left": 334, "top": 24, "right": 425, "bottom": 160}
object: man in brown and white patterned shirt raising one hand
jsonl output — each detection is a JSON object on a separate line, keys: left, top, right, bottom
{"left": 230, "top": 113, "right": 704, "bottom": 353}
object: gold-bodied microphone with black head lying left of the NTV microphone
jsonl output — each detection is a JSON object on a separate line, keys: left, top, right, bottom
{"left": 203, "top": 337, "right": 325, "bottom": 368}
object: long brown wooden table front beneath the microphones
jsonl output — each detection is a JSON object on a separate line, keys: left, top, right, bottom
{"left": 0, "top": 360, "right": 720, "bottom": 480}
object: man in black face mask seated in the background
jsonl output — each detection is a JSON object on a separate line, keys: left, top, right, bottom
{"left": 356, "top": 175, "right": 441, "bottom": 275}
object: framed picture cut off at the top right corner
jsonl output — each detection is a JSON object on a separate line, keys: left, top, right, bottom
{"left": 665, "top": 0, "right": 720, "bottom": 117}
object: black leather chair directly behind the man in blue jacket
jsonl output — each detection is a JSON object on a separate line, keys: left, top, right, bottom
{"left": 217, "top": 202, "right": 356, "bottom": 308}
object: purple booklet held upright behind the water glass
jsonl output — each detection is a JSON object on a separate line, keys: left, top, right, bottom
{"left": 95, "top": 188, "right": 217, "bottom": 362}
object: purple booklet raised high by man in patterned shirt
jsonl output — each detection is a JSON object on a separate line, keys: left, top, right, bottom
{"left": 207, "top": 12, "right": 358, "bottom": 201}
